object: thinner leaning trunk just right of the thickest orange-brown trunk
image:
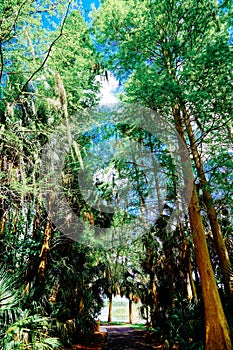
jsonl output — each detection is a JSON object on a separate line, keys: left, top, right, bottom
{"left": 182, "top": 106, "right": 233, "bottom": 295}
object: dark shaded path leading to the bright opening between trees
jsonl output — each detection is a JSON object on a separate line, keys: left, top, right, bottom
{"left": 103, "top": 326, "right": 161, "bottom": 350}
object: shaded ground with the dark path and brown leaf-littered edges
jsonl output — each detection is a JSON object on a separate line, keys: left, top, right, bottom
{"left": 69, "top": 325, "right": 178, "bottom": 350}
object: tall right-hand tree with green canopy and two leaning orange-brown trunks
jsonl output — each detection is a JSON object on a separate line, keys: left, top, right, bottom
{"left": 94, "top": 0, "right": 232, "bottom": 349}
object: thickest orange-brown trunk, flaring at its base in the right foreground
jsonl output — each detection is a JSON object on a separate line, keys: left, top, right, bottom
{"left": 173, "top": 104, "right": 231, "bottom": 350}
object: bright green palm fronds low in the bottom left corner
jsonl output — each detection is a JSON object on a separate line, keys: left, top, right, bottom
{"left": 0, "top": 269, "right": 61, "bottom": 350}
